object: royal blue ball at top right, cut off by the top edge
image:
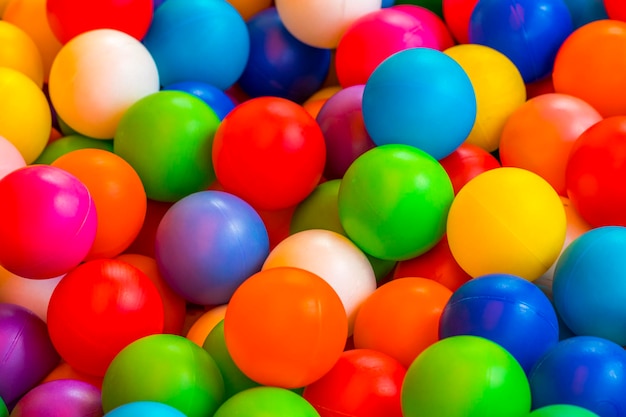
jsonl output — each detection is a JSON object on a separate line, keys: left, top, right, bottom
{"left": 469, "top": 0, "right": 574, "bottom": 83}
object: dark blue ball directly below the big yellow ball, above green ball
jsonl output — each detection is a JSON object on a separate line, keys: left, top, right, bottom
{"left": 439, "top": 274, "right": 559, "bottom": 373}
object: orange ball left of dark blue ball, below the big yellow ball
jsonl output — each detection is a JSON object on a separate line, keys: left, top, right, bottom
{"left": 353, "top": 277, "right": 452, "bottom": 368}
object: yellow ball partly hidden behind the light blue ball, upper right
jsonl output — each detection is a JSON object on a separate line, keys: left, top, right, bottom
{"left": 444, "top": 44, "right": 526, "bottom": 152}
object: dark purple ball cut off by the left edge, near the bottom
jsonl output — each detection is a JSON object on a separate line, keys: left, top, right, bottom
{"left": 0, "top": 303, "right": 60, "bottom": 409}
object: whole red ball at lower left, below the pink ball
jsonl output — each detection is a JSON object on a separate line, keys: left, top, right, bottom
{"left": 48, "top": 259, "right": 164, "bottom": 376}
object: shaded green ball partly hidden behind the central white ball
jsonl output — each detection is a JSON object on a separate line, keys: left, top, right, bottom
{"left": 289, "top": 179, "right": 396, "bottom": 282}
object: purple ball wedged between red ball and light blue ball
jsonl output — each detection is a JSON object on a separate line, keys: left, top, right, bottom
{"left": 317, "top": 85, "right": 375, "bottom": 180}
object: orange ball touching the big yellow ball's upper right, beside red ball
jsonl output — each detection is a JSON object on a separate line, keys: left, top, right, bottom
{"left": 499, "top": 93, "right": 602, "bottom": 196}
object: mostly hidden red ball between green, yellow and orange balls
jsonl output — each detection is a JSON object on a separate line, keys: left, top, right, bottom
{"left": 393, "top": 235, "right": 472, "bottom": 291}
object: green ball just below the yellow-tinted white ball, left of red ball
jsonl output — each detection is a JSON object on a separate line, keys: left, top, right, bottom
{"left": 113, "top": 90, "right": 220, "bottom": 202}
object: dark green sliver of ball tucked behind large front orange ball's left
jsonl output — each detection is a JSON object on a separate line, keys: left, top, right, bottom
{"left": 202, "top": 320, "right": 260, "bottom": 398}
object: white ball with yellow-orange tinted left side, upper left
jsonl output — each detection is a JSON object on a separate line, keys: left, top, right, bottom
{"left": 48, "top": 29, "right": 160, "bottom": 139}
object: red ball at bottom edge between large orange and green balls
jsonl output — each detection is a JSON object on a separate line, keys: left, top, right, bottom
{"left": 302, "top": 349, "right": 406, "bottom": 417}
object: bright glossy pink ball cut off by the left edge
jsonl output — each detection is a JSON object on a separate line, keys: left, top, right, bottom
{"left": 0, "top": 165, "right": 97, "bottom": 279}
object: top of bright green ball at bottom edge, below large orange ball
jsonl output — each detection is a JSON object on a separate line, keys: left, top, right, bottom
{"left": 213, "top": 386, "right": 320, "bottom": 417}
